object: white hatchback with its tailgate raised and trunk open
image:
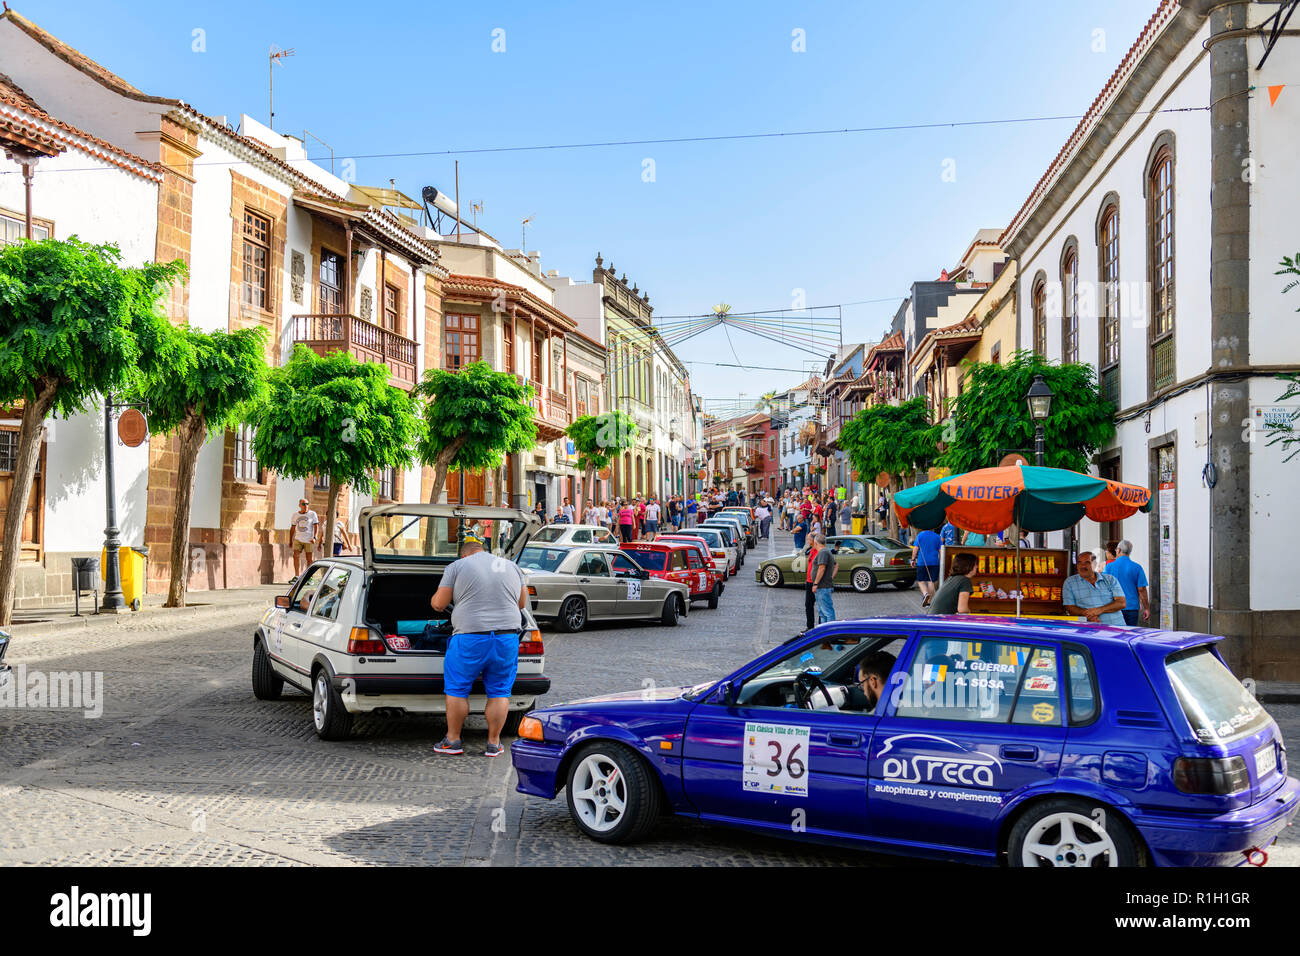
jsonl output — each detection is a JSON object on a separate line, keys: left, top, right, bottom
{"left": 252, "top": 503, "right": 551, "bottom": 740}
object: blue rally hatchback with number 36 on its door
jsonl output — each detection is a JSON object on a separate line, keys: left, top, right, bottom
{"left": 511, "top": 617, "right": 1300, "bottom": 866}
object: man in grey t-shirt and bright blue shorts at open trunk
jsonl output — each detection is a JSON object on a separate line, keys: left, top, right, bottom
{"left": 430, "top": 535, "right": 528, "bottom": 757}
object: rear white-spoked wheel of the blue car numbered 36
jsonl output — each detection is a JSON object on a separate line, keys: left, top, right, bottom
{"left": 1008, "top": 799, "right": 1141, "bottom": 866}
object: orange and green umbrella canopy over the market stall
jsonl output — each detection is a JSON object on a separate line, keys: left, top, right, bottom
{"left": 893, "top": 464, "right": 1152, "bottom": 535}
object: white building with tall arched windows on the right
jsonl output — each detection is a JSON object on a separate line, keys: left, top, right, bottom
{"left": 1001, "top": 0, "right": 1300, "bottom": 680}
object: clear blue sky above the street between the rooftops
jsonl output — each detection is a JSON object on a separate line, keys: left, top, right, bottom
{"left": 20, "top": 0, "right": 1156, "bottom": 401}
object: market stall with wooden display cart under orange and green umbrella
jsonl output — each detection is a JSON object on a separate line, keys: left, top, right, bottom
{"left": 893, "top": 464, "right": 1151, "bottom": 617}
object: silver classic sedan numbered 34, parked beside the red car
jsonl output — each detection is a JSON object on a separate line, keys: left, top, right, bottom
{"left": 519, "top": 542, "right": 690, "bottom": 631}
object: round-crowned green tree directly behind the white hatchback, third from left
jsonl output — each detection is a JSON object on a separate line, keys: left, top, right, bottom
{"left": 247, "top": 345, "right": 424, "bottom": 554}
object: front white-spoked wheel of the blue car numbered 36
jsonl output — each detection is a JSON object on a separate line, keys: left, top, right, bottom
{"left": 567, "top": 740, "right": 659, "bottom": 843}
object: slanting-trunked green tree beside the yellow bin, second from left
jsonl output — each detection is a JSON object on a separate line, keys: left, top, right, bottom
{"left": 133, "top": 325, "right": 267, "bottom": 607}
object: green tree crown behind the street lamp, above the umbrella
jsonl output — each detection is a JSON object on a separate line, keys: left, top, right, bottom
{"left": 939, "top": 351, "right": 1115, "bottom": 473}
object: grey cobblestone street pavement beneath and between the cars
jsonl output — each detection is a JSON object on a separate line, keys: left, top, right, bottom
{"left": 0, "top": 535, "right": 1300, "bottom": 866}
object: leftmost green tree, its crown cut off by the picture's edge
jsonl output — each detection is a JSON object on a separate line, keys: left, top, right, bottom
{"left": 0, "top": 237, "right": 186, "bottom": 624}
